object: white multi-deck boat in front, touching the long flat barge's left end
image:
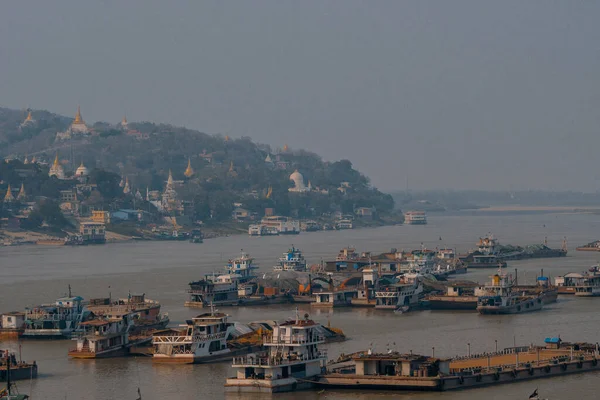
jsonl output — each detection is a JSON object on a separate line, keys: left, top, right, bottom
{"left": 225, "top": 311, "right": 327, "bottom": 393}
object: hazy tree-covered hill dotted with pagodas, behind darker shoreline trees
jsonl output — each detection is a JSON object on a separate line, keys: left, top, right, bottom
{"left": 0, "top": 108, "right": 394, "bottom": 217}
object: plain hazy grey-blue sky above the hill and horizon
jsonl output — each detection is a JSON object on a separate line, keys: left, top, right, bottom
{"left": 0, "top": 0, "right": 600, "bottom": 191}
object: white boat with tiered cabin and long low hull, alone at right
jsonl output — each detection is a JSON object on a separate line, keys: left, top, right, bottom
{"left": 477, "top": 271, "right": 544, "bottom": 314}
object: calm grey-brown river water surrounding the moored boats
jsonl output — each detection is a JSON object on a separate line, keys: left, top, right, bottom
{"left": 0, "top": 212, "right": 600, "bottom": 400}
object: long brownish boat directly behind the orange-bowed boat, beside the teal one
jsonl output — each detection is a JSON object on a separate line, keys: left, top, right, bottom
{"left": 87, "top": 293, "right": 169, "bottom": 333}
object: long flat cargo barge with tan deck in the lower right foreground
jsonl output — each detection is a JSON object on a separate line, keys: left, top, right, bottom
{"left": 313, "top": 338, "right": 600, "bottom": 391}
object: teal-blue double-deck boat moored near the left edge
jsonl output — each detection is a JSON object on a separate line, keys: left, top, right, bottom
{"left": 22, "top": 287, "right": 89, "bottom": 339}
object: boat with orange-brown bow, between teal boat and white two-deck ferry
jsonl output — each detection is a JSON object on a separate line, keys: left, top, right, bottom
{"left": 69, "top": 310, "right": 151, "bottom": 359}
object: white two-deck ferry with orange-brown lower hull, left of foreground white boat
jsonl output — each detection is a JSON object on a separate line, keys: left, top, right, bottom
{"left": 152, "top": 306, "right": 258, "bottom": 364}
